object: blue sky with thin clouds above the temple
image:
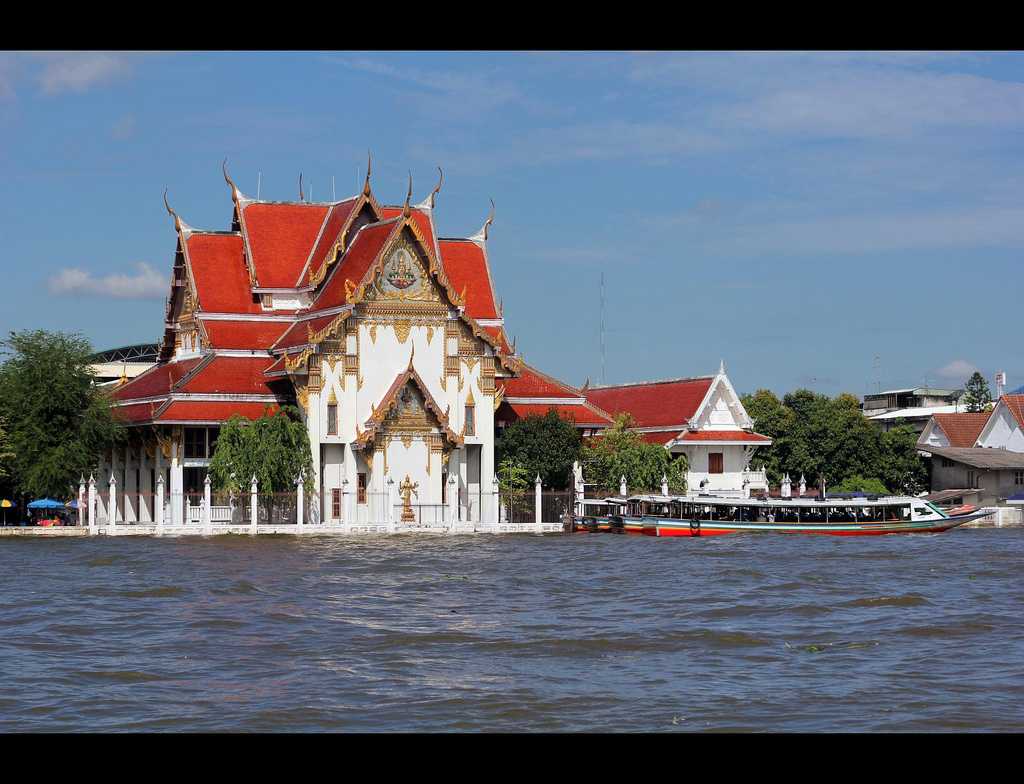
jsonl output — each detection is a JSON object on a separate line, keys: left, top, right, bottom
{"left": 0, "top": 52, "right": 1024, "bottom": 395}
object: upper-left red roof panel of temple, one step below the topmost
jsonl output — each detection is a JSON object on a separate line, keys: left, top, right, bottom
{"left": 187, "top": 233, "right": 260, "bottom": 313}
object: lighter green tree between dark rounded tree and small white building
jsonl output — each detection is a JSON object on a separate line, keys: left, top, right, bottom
{"left": 583, "top": 413, "right": 687, "bottom": 493}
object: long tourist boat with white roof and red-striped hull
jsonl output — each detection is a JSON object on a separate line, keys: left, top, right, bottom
{"left": 622, "top": 495, "right": 990, "bottom": 536}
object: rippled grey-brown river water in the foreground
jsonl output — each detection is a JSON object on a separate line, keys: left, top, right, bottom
{"left": 0, "top": 529, "right": 1024, "bottom": 732}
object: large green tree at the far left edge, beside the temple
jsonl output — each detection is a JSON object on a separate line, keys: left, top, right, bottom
{"left": 0, "top": 330, "right": 124, "bottom": 498}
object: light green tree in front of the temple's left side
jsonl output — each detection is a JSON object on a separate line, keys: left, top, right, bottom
{"left": 210, "top": 405, "right": 313, "bottom": 493}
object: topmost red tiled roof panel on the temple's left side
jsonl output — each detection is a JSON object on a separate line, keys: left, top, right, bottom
{"left": 242, "top": 202, "right": 328, "bottom": 289}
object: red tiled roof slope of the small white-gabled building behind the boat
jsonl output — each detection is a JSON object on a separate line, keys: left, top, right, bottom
{"left": 584, "top": 376, "right": 714, "bottom": 428}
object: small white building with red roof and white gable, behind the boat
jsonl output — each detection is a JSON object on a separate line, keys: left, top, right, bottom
{"left": 581, "top": 363, "right": 771, "bottom": 497}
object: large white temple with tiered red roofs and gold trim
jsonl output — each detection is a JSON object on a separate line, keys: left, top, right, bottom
{"left": 98, "top": 161, "right": 598, "bottom": 523}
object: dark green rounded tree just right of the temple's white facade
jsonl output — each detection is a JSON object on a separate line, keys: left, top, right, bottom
{"left": 495, "top": 408, "right": 583, "bottom": 490}
